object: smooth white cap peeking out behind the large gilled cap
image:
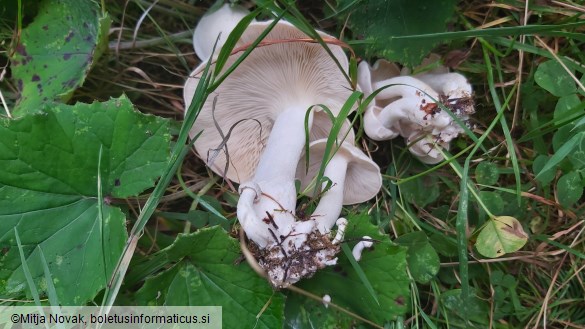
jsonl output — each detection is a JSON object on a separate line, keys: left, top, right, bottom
{"left": 193, "top": 3, "right": 250, "bottom": 61}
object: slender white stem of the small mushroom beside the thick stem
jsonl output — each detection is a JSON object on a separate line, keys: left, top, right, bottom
{"left": 312, "top": 153, "right": 347, "bottom": 234}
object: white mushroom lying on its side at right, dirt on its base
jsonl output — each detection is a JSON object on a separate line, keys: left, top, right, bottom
{"left": 358, "top": 60, "right": 474, "bottom": 164}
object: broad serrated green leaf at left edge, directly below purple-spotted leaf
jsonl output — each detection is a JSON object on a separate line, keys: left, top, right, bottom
{"left": 0, "top": 96, "right": 170, "bottom": 197}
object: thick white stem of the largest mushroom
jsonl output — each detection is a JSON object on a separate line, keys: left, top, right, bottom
{"left": 237, "top": 105, "right": 312, "bottom": 250}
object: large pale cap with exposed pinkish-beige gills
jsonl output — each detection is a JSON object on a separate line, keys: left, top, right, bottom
{"left": 183, "top": 21, "right": 352, "bottom": 182}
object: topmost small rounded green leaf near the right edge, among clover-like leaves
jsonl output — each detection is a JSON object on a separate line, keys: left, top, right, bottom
{"left": 534, "top": 60, "right": 577, "bottom": 97}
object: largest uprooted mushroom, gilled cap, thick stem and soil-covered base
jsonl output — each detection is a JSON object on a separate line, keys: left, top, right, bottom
{"left": 184, "top": 16, "right": 379, "bottom": 287}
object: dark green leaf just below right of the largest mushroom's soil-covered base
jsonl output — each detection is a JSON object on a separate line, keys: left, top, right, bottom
{"left": 298, "top": 215, "right": 410, "bottom": 325}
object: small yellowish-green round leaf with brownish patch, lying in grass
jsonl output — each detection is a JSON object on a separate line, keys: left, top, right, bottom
{"left": 475, "top": 216, "right": 528, "bottom": 258}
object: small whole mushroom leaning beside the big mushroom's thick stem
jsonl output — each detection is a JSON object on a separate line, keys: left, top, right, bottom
{"left": 297, "top": 139, "right": 382, "bottom": 234}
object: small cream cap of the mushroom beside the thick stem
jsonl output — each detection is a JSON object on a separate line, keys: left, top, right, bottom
{"left": 297, "top": 139, "right": 382, "bottom": 205}
